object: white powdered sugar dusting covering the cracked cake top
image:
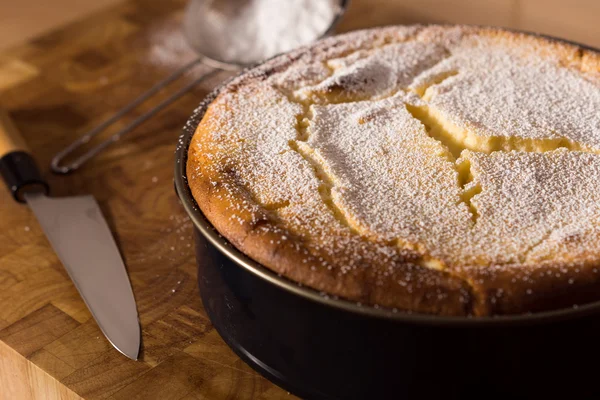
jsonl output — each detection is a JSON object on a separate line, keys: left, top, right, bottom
{"left": 188, "top": 28, "right": 600, "bottom": 316}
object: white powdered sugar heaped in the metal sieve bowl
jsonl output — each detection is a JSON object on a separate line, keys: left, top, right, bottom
{"left": 184, "top": 0, "right": 340, "bottom": 64}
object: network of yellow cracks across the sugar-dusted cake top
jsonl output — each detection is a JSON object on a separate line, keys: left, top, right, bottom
{"left": 286, "top": 50, "right": 595, "bottom": 270}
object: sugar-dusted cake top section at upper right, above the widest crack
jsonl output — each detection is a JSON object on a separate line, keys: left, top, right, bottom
{"left": 413, "top": 39, "right": 600, "bottom": 149}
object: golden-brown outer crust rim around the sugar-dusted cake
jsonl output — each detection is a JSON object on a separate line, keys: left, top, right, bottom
{"left": 187, "top": 26, "right": 600, "bottom": 315}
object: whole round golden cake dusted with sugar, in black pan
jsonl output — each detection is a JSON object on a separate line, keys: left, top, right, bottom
{"left": 187, "top": 25, "right": 600, "bottom": 316}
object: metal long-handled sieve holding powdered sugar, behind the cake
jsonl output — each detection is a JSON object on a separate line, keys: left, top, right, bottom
{"left": 51, "top": 0, "right": 350, "bottom": 174}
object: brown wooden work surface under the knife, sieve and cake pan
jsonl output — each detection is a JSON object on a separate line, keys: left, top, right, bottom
{"left": 0, "top": 0, "right": 600, "bottom": 400}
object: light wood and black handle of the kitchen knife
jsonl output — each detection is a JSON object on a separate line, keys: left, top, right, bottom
{"left": 0, "top": 109, "right": 50, "bottom": 203}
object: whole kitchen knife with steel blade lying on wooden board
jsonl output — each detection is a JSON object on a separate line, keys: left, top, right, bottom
{"left": 0, "top": 109, "right": 140, "bottom": 360}
